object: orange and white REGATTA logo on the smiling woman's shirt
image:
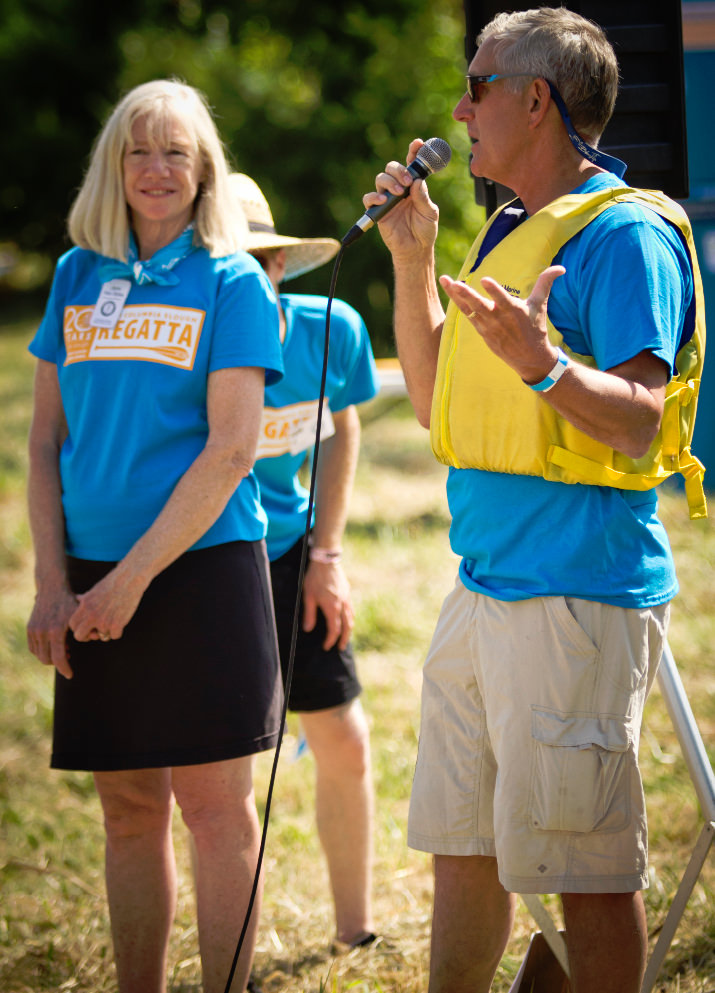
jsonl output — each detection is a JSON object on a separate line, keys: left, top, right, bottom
{"left": 63, "top": 304, "right": 206, "bottom": 370}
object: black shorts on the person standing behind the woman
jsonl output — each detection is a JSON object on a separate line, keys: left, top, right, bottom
{"left": 271, "top": 541, "right": 362, "bottom": 711}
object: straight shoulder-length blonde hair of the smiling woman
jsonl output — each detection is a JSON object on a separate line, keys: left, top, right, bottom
{"left": 68, "top": 79, "right": 248, "bottom": 262}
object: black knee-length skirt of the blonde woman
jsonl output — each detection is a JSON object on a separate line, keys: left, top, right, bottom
{"left": 51, "top": 541, "right": 283, "bottom": 771}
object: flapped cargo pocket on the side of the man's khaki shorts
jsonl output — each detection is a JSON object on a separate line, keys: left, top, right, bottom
{"left": 529, "top": 707, "right": 632, "bottom": 832}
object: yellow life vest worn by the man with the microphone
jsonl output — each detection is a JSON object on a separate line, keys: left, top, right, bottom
{"left": 430, "top": 187, "right": 707, "bottom": 518}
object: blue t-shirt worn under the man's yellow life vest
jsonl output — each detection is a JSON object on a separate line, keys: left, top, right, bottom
{"left": 447, "top": 174, "right": 693, "bottom": 608}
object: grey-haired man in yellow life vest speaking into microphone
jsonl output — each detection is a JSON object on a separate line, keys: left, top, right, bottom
{"left": 363, "top": 8, "right": 706, "bottom": 993}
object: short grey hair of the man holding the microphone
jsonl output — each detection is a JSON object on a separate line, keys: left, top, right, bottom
{"left": 477, "top": 7, "right": 618, "bottom": 143}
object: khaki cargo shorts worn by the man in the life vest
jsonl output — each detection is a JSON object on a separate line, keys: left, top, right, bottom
{"left": 407, "top": 580, "right": 669, "bottom": 893}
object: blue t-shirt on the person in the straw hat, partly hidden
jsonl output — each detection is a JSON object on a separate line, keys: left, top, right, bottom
{"left": 254, "top": 294, "right": 379, "bottom": 561}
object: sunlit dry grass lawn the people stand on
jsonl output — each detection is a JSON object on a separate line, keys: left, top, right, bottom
{"left": 0, "top": 304, "right": 715, "bottom": 993}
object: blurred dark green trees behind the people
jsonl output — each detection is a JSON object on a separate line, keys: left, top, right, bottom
{"left": 0, "top": 0, "right": 483, "bottom": 355}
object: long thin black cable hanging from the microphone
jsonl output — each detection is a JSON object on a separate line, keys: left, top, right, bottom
{"left": 224, "top": 244, "right": 346, "bottom": 993}
